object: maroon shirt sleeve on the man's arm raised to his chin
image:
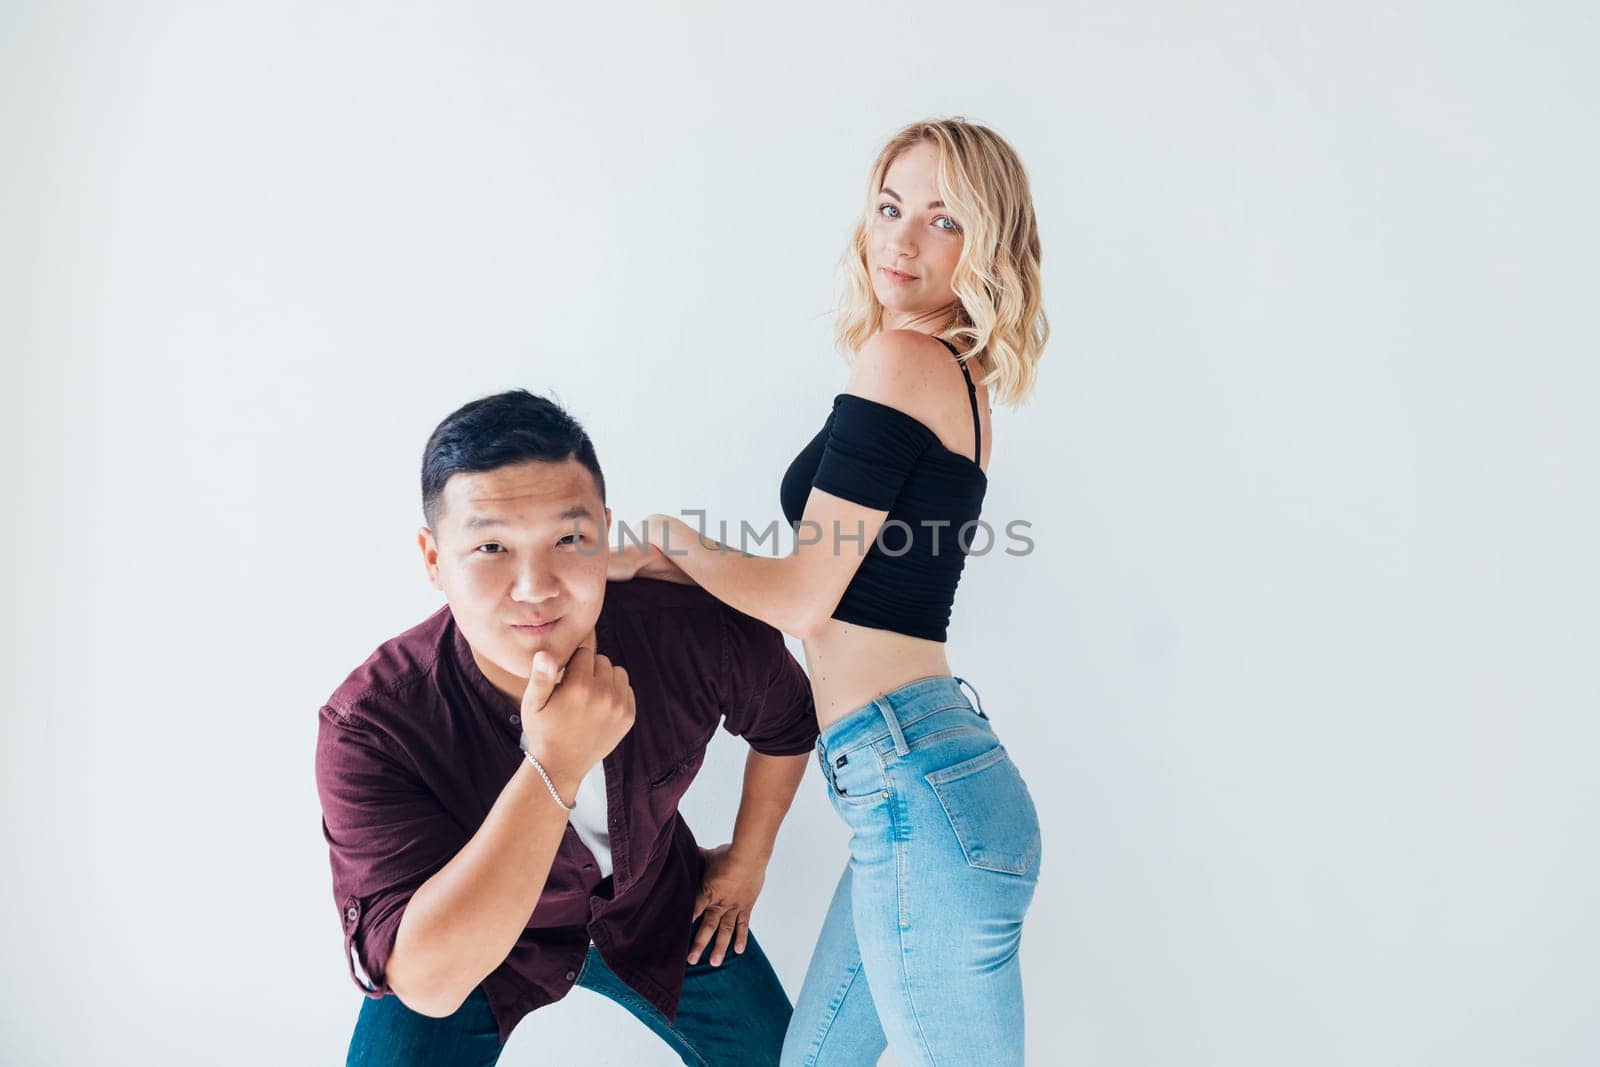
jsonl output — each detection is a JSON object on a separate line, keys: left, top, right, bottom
{"left": 317, "top": 705, "right": 459, "bottom": 997}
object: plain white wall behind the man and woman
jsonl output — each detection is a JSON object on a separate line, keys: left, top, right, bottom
{"left": 0, "top": 0, "right": 1600, "bottom": 1067}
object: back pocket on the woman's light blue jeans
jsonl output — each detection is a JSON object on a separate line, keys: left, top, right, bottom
{"left": 923, "top": 745, "right": 1040, "bottom": 875}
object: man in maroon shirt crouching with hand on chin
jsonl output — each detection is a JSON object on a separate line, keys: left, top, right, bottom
{"left": 317, "top": 390, "right": 818, "bottom": 1064}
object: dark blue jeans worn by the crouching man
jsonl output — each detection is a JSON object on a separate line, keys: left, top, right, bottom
{"left": 344, "top": 934, "right": 792, "bottom": 1067}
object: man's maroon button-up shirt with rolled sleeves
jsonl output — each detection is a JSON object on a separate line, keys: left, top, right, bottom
{"left": 317, "top": 579, "right": 818, "bottom": 1041}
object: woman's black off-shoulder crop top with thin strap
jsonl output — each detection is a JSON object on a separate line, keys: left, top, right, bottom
{"left": 779, "top": 338, "right": 989, "bottom": 641}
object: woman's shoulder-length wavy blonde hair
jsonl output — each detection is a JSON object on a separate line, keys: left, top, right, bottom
{"left": 834, "top": 117, "right": 1050, "bottom": 406}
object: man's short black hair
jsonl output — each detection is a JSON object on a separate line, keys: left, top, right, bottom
{"left": 422, "top": 389, "right": 605, "bottom": 526}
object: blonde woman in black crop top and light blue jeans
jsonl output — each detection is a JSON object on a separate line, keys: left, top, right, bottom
{"left": 613, "top": 118, "right": 1048, "bottom": 1065}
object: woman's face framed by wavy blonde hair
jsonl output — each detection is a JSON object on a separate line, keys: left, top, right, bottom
{"left": 867, "top": 141, "right": 963, "bottom": 330}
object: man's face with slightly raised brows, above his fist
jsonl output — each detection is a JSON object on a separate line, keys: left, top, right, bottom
{"left": 418, "top": 459, "right": 611, "bottom": 696}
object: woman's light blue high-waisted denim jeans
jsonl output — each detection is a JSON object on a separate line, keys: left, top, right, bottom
{"left": 782, "top": 677, "right": 1040, "bottom": 1067}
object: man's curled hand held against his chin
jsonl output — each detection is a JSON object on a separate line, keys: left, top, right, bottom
{"left": 522, "top": 630, "right": 634, "bottom": 797}
